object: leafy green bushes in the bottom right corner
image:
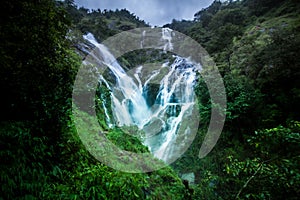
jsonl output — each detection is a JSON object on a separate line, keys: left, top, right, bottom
{"left": 224, "top": 122, "right": 300, "bottom": 199}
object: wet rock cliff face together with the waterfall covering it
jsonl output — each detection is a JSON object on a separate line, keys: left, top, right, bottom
{"left": 78, "top": 28, "right": 201, "bottom": 163}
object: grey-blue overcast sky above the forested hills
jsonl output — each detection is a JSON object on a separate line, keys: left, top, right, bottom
{"left": 75, "top": 0, "right": 213, "bottom": 26}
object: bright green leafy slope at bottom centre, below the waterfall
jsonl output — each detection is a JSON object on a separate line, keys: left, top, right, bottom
{"left": 48, "top": 113, "right": 190, "bottom": 199}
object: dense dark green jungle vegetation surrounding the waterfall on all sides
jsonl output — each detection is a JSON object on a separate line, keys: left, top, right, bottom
{"left": 0, "top": 0, "right": 300, "bottom": 199}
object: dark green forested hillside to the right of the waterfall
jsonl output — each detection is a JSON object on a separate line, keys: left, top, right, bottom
{"left": 169, "top": 0, "right": 300, "bottom": 199}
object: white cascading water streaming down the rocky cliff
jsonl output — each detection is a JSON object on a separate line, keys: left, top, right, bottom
{"left": 84, "top": 28, "right": 200, "bottom": 162}
